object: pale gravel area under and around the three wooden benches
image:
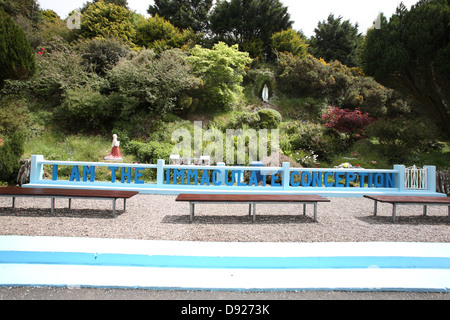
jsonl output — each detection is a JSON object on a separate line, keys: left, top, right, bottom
{"left": 0, "top": 195, "right": 450, "bottom": 242}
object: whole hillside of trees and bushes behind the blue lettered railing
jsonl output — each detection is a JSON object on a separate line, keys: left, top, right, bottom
{"left": 0, "top": 0, "right": 450, "bottom": 182}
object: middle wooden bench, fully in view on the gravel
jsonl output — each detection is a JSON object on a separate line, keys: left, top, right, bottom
{"left": 176, "top": 194, "right": 330, "bottom": 222}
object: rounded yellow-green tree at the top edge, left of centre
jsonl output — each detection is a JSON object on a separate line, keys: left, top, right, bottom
{"left": 81, "top": 1, "right": 135, "bottom": 43}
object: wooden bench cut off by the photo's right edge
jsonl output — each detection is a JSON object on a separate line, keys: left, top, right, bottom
{"left": 364, "top": 195, "right": 450, "bottom": 222}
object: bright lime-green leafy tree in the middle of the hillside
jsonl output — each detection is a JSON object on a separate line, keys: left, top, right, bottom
{"left": 187, "top": 42, "right": 252, "bottom": 110}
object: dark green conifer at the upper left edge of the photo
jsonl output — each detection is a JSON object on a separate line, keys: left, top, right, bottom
{"left": 0, "top": 10, "right": 36, "bottom": 88}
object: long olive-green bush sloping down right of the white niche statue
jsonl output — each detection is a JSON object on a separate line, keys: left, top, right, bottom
{"left": 277, "top": 54, "right": 409, "bottom": 117}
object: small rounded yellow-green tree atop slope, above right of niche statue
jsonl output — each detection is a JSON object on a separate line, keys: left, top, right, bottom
{"left": 272, "top": 29, "right": 308, "bottom": 57}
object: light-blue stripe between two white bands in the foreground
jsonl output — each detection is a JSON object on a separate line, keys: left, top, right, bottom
{"left": 0, "top": 251, "right": 450, "bottom": 269}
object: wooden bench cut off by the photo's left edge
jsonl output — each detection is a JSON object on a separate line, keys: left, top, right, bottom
{"left": 0, "top": 187, "right": 139, "bottom": 217}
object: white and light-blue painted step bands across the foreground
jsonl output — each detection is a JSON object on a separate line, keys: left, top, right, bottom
{"left": 0, "top": 236, "right": 450, "bottom": 293}
